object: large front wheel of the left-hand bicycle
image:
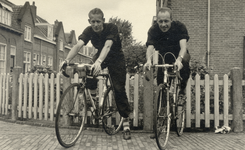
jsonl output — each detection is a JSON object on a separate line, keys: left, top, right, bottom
{"left": 55, "top": 83, "right": 87, "bottom": 148}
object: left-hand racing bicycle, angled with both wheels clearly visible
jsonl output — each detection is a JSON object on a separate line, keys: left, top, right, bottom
{"left": 55, "top": 63, "right": 123, "bottom": 148}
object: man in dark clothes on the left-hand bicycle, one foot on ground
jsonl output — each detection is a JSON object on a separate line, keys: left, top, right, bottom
{"left": 61, "top": 8, "right": 131, "bottom": 140}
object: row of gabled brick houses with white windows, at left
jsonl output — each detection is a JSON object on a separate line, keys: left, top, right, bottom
{"left": 0, "top": 0, "right": 95, "bottom": 73}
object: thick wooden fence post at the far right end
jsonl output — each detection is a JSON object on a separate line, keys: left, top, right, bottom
{"left": 231, "top": 67, "right": 243, "bottom": 132}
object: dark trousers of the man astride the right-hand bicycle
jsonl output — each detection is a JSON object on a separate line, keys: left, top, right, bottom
{"left": 157, "top": 53, "right": 190, "bottom": 94}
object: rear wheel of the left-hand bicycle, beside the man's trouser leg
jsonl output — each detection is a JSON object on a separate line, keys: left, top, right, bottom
{"left": 102, "top": 87, "right": 123, "bottom": 135}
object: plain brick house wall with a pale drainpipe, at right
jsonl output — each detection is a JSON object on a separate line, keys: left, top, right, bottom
{"left": 156, "top": 0, "right": 245, "bottom": 76}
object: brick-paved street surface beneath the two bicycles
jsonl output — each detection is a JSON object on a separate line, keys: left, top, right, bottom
{"left": 0, "top": 121, "right": 245, "bottom": 150}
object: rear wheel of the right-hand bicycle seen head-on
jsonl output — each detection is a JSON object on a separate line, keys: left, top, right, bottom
{"left": 174, "top": 83, "right": 186, "bottom": 136}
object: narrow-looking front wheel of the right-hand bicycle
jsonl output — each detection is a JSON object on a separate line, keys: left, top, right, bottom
{"left": 153, "top": 84, "right": 171, "bottom": 150}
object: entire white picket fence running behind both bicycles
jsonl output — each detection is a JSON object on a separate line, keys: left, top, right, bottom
{"left": 0, "top": 74, "right": 245, "bottom": 128}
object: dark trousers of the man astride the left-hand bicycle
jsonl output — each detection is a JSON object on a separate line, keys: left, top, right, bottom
{"left": 86, "top": 54, "right": 131, "bottom": 118}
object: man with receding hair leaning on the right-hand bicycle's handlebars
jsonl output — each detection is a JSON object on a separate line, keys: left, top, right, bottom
{"left": 145, "top": 7, "right": 190, "bottom": 138}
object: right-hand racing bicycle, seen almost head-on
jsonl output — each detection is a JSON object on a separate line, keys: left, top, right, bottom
{"left": 146, "top": 52, "right": 186, "bottom": 150}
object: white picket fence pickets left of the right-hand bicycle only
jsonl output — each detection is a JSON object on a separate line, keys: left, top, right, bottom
{"left": 0, "top": 73, "right": 143, "bottom": 126}
